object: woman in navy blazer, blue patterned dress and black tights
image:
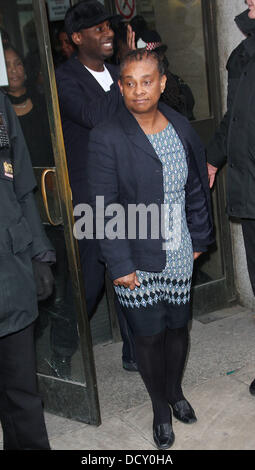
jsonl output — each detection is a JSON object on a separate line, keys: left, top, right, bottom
{"left": 87, "top": 50, "right": 213, "bottom": 449}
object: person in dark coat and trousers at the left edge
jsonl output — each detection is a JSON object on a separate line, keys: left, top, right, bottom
{"left": 0, "top": 92, "right": 55, "bottom": 450}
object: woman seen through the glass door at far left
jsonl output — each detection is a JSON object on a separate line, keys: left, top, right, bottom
{"left": 4, "top": 45, "right": 54, "bottom": 167}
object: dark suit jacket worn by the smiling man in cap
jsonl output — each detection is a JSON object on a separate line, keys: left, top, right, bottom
{"left": 56, "top": 56, "right": 122, "bottom": 203}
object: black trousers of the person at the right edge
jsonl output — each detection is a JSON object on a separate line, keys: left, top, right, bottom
{"left": 241, "top": 219, "right": 255, "bottom": 295}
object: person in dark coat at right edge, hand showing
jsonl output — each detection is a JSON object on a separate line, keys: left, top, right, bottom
{"left": 207, "top": 0, "right": 255, "bottom": 395}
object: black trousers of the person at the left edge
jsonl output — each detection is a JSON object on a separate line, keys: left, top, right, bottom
{"left": 0, "top": 324, "right": 50, "bottom": 450}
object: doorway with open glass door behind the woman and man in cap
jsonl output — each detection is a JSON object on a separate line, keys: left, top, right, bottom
{"left": 0, "top": 0, "right": 235, "bottom": 425}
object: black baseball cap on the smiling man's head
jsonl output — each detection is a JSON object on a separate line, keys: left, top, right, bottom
{"left": 65, "top": 0, "right": 112, "bottom": 37}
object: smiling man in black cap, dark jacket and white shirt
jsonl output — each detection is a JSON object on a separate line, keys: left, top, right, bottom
{"left": 56, "top": 0, "right": 137, "bottom": 371}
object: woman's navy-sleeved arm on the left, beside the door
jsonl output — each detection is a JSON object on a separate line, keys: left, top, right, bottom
{"left": 86, "top": 128, "right": 136, "bottom": 280}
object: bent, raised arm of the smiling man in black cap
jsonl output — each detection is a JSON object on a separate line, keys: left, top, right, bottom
{"left": 56, "top": 71, "right": 122, "bottom": 129}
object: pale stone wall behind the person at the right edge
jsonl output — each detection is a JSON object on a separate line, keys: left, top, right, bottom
{"left": 215, "top": 0, "right": 255, "bottom": 308}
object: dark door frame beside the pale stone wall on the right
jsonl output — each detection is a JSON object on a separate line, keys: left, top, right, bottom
{"left": 190, "top": 0, "right": 237, "bottom": 316}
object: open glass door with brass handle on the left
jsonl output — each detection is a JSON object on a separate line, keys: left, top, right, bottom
{"left": 0, "top": 0, "right": 101, "bottom": 425}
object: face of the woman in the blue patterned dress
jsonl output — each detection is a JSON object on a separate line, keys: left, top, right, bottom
{"left": 119, "top": 58, "right": 167, "bottom": 114}
